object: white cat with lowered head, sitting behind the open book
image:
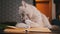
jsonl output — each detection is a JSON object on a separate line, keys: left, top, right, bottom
{"left": 16, "top": 1, "right": 52, "bottom": 28}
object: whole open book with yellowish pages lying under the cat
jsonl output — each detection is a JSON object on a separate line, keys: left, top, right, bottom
{"left": 4, "top": 26, "right": 51, "bottom": 33}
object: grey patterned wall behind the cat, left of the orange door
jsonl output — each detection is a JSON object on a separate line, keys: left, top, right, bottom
{"left": 0, "top": 0, "right": 33, "bottom": 22}
